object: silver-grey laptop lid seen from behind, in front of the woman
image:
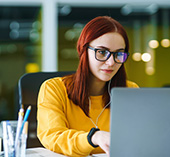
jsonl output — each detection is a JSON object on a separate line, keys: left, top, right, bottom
{"left": 110, "top": 88, "right": 170, "bottom": 157}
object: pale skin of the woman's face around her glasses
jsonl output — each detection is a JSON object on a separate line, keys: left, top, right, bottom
{"left": 88, "top": 32, "right": 125, "bottom": 82}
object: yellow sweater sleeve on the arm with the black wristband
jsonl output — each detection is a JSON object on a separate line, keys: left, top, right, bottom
{"left": 37, "top": 79, "right": 94, "bottom": 156}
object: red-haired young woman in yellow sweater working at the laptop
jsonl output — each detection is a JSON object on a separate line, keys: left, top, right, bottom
{"left": 38, "top": 16, "right": 138, "bottom": 156}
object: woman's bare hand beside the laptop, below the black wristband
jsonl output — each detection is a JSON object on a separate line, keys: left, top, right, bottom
{"left": 91, "top": 131, "right": 110, "bottom": 155}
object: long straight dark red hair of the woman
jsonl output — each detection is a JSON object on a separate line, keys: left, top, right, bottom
{"left": 63, "top": 16, "right": 129, "bottom": 116}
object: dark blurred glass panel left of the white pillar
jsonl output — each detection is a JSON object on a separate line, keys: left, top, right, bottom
{"left": 0, "top": 6, "right": 42, "bottom": 121}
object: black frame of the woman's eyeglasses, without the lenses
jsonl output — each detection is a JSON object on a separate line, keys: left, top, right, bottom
{"left": 88, "top": 46, "right": 130, "bottom": 64}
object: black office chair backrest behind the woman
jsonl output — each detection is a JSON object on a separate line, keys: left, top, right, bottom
{"left": 18, "top": 71, "right": 74, "bottom": 148}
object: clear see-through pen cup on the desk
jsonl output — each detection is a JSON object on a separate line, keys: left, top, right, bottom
{"left": 2, "top": 121, "right": 28, "bottom": 157}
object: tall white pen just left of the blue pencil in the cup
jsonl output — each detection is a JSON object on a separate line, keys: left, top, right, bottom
{"left": 15, "top": 108, "right": 24, "bottom": 147}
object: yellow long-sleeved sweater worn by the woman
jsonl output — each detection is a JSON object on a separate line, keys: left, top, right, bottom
{"left": 37, "top": 77, "right": 138, "bottom": 156}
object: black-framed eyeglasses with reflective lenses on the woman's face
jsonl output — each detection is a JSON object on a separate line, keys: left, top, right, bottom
{"left": 88, "top": 46, "right": 129, "bottom": 64}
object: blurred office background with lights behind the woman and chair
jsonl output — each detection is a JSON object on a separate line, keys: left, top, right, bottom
{"left": 0, "top": 0, "right": 170, "bottom": 121}
